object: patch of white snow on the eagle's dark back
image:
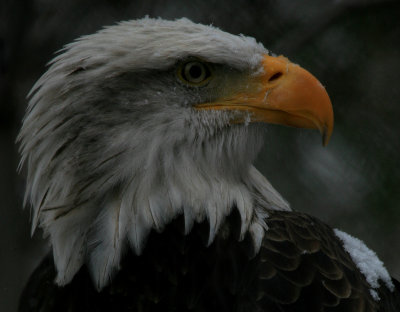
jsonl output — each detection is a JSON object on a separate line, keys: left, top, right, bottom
{"left": 334, "top": 229, "right": 394, "bottom": 301}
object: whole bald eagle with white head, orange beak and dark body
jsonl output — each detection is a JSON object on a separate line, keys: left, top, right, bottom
{"left": 19, "top": 18, "right": 400, "bottom": 312}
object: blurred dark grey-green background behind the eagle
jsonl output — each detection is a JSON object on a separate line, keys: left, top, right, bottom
{"left": 0, "top": 0, "right": 400, "bottom": 312}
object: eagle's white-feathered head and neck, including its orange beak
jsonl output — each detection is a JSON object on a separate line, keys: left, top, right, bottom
{"left": 19, "top": 18, "right": 333, "bottom": 289}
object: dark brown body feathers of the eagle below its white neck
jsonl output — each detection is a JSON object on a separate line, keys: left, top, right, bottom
{"left": 20, "top": 211, "right": 400, "bottom": 312}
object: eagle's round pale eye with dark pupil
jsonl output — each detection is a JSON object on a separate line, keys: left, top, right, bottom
{"left": 178, "top": 61, "right": 211, "bottom": 86}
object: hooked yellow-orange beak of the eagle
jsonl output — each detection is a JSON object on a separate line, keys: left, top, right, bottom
{"left": 196, "top": 55, "right": 333, "bottom": 145}
